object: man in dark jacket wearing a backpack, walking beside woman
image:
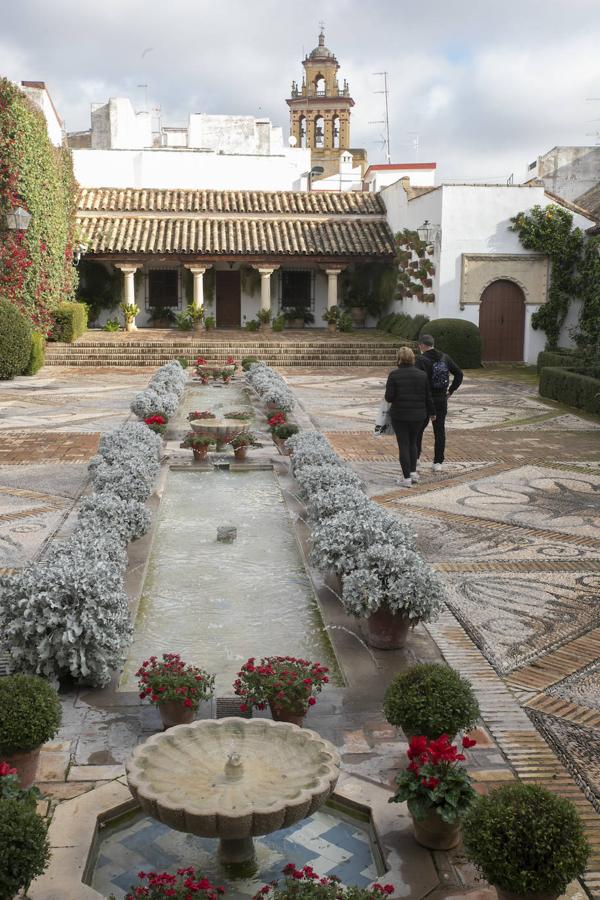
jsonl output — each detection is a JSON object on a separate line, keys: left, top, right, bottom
{"left": 415, "top": 334, "right": 463, "bottom": 472}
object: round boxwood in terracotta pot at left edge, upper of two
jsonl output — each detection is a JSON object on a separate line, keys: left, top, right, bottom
{"left": 0, "top": 675, "right": 61, "bottom": 790}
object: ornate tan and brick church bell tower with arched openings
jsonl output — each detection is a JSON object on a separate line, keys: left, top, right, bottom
{"left": 286, "top": 27, "right": 366, "bottom": 175}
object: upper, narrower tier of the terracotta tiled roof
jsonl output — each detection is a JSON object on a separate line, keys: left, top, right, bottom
{"left": 79, "top": 188, "right": 385, "bottom": 216}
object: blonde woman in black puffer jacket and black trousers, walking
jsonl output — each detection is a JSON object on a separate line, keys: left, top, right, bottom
{"left": 385, "top": 347, "right": 435, "bottom": 487}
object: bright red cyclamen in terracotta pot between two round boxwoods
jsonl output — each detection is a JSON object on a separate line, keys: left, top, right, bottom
{"left": 389, "top": 734, "right": 476, "bottom": 850}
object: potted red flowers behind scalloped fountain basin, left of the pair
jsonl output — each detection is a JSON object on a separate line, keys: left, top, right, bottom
{"left": 135, "top": 653, "right": 215, "bottom": 728}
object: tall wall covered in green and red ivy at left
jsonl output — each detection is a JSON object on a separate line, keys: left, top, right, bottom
{"left": 0, "top": 78, "right": 77, "bottom": 335}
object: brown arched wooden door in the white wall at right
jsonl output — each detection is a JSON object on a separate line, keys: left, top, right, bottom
{"left": 479, "top": 278, "right": 525, "bottom": 362}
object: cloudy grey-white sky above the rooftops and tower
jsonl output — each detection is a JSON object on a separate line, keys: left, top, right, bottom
{"left": 0, "top": 0, "right": 600, "bottom": 181}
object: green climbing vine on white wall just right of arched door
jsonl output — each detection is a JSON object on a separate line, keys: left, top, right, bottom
{"left": 511, "top": 205, "right": 584, "bottom": 350}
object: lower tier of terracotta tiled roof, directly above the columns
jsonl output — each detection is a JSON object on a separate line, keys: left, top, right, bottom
{"left": 79, "top": 215, "right": 395, "bottom": 257}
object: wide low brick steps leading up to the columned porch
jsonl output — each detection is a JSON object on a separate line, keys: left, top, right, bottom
{"left": 46, "top": 339, "right": 404, "bottom": 368}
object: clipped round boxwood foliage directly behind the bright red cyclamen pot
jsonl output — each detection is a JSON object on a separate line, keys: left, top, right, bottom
{"left": 383, "top": 663, "right": 479, "bottom": 739}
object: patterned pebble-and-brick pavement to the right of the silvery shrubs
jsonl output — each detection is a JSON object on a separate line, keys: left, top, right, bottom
{"left": 286, "top": 370, "right": 600, "bottom": 896}
